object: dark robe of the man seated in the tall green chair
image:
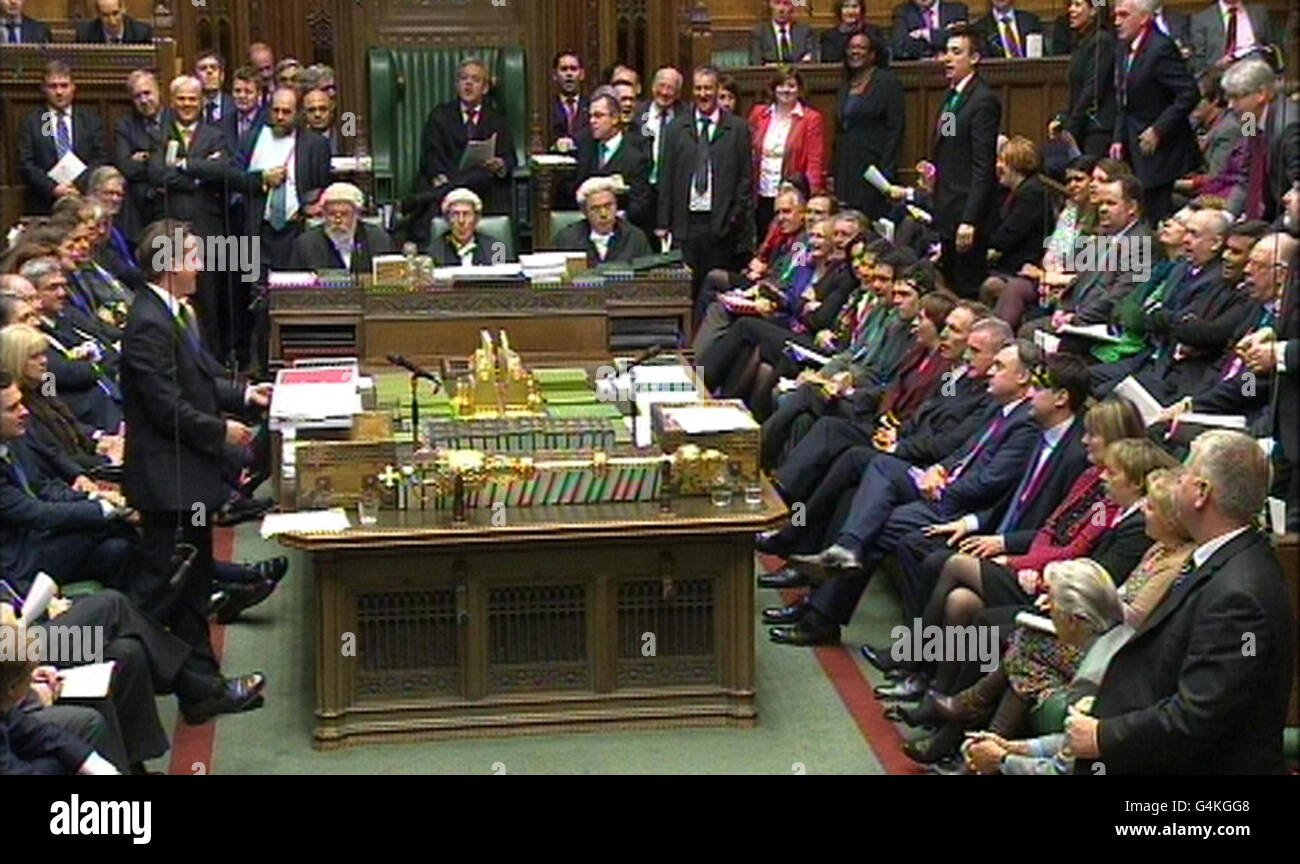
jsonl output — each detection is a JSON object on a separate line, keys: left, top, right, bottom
{"left": 416, "top": 99, "right": 515, "bottom": 222}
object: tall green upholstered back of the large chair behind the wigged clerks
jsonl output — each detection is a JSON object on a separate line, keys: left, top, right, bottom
{"left": 369, "top": 45, "right": 528, "bottom": 199}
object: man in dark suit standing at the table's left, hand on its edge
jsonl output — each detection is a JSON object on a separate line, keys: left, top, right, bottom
{"left": 122, "top": 220, "right": 270, "bottom": 711}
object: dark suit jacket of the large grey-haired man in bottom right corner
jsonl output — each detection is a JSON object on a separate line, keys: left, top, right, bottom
{"left": 1092, "top": 529, "right": 1296, "bottom": 774}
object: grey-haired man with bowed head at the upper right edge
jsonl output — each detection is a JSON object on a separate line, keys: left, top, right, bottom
{"left": 1223, "top": 57, "right": 1300, "bottom": 221}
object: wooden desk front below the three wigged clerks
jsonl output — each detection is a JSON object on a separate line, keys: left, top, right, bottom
{"left": 270, "top": 268, "right": 693, "bottom": 365}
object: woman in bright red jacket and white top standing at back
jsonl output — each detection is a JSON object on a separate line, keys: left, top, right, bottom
{"left": 749, "top": 66, "right": 826, "bottom": 236}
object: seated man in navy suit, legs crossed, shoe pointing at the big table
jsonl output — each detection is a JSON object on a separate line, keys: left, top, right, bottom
{"left": 770, "top": 339, "right": 1041, "bottom": 644}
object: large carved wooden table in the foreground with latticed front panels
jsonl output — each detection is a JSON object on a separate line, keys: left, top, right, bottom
{"left": 280, "top": 486, "right": 787, "bottom": 750}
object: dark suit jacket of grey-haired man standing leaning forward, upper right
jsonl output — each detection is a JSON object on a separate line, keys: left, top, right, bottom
{"left": 1113, "top": 26, "right": 1200, "bottom": 188}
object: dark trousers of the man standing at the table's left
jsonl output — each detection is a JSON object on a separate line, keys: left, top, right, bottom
{"left": 140, "top": 511, "right": 220, "bottom": 676}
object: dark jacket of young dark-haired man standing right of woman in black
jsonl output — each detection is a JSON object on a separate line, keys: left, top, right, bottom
{"left": 931, "top": 74, "right": 1002, "bottom": 236}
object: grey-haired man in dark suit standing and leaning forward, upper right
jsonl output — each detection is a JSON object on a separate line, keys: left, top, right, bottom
{"left": 1110, "top": 0, "right": 1200, "bottom": 225}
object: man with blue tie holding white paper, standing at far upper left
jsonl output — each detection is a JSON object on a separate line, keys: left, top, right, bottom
{"left": 18, "top": 60, "right": 108, "bottom": 214}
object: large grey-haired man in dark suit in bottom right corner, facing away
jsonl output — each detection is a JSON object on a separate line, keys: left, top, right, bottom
{"left": 1065, "top": 430, "right": 1296, "bottom": 774}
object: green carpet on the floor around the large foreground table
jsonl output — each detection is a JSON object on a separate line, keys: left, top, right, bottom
{"left": 192, "top": 525, "right": 897, "bottom": 774}
